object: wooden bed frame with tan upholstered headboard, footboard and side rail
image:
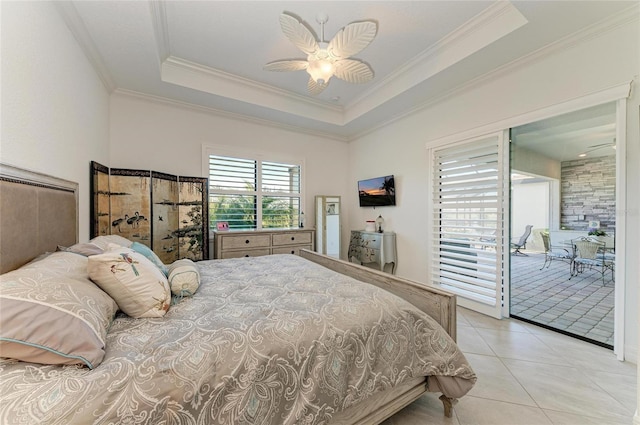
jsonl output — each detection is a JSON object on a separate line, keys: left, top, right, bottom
{"left": 0, "top": 164, "right": 456, "bottom": 425}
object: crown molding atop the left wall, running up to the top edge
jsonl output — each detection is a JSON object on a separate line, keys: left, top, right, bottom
{"left": 53, "top": 1, "right": 116, "bottom": 93}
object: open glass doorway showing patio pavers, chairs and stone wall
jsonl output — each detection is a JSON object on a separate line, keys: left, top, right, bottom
{"left": 510, "top": 103, "right": 617, "bottom": 348}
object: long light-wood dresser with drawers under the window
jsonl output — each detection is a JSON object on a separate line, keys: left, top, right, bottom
{"left": 213, "top": 229, "right": 315, "bottom": 259}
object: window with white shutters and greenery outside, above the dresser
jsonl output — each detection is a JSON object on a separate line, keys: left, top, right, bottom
{"left": 208, "top": 153, "right": 302, "bottom": 230}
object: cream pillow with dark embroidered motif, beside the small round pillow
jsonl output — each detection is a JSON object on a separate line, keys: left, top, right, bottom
{"left": 87, "top": 244, "right": 171, "bottom": 318}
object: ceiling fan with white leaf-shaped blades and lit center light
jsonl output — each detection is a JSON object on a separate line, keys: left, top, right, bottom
{"left": 264, "top": 12, "right": 378, "bottom": 95}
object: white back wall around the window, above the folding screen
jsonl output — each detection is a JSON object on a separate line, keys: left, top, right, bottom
{"left": 110, "top": 94, "right": 355, "bottom": 243}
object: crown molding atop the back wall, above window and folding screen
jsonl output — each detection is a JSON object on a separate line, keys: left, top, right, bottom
{"left": 112, "top": 88, "right": 349, "bottom": 142}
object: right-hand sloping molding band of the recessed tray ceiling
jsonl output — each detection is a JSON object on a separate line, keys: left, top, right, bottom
{"left": 345, "top": 1, "right": 528, "bottom": 122}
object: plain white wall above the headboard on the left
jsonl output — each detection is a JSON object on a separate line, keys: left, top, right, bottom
{"left": 0, "top": 2, "right": 109, "bottom": 241}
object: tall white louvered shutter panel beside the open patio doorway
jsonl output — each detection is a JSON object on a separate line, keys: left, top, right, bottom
{"left": 431, "top": 133, "right": 508, "bottom": 318}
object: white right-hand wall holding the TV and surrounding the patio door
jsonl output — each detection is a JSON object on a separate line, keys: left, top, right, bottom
{"left": 344, "top": 16, "right": 640, "bottom": 359}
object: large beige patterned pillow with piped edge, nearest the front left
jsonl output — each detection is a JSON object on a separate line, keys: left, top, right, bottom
{"left": 0, "top": 260, "right": 118, "bottom": 369}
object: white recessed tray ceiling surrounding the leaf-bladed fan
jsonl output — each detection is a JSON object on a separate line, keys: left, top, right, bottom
{"left": 56, "top": 0, "right": 635, "bottom": 141}
